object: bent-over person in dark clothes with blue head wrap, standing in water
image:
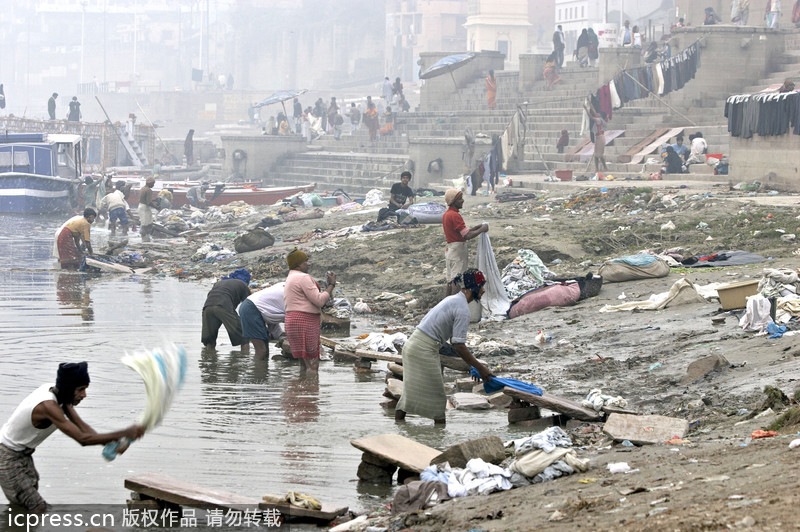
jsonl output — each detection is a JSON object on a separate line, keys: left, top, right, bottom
{"left": 200, "top": 268, "right": 250, "bottom": 354}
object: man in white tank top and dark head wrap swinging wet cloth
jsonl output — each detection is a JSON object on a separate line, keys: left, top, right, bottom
{"left": 0, "top": 362, "right": 144, "bottom": 512}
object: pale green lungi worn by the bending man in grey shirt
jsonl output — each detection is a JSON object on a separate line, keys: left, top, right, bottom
{"left": 397, "top": 329, "right": 447, "bottom": 420}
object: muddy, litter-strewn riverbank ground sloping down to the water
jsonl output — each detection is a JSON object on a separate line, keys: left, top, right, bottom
{"left": 125, "top": 182, "right": 800, "bottom": 531}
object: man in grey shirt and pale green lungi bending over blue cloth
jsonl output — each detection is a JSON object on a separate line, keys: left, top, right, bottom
{"left": 395, "top": 269, "right": 492, "bottom": 425}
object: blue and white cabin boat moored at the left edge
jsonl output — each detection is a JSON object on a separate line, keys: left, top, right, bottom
{"left": 0, "top": 133, "right": 82, "bottom": 214}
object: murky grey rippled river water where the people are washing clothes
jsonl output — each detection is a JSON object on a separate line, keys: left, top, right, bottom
{"left": 0, "top": 216, "right": 516, "bottom": 510}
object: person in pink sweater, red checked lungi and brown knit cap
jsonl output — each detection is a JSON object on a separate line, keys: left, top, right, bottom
{"left": 283, "top": 248, "right": 336, "bottom": 371}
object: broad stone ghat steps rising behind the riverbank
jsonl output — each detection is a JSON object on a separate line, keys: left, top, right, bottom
{"left": 270, "top": 32, "right": 800, "bottom": 196}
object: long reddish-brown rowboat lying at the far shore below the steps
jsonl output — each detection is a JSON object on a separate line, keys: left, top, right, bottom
{"left": 126, "top": 181, "right": 317, "bottom": 209}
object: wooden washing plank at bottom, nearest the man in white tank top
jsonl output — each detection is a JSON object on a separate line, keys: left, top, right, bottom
{"left": 125, "top": 473, "right": 260, "bottom": 509}
